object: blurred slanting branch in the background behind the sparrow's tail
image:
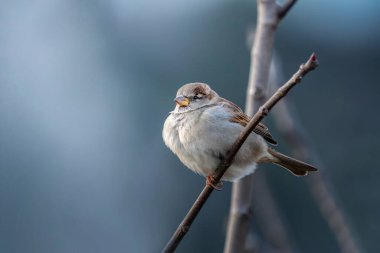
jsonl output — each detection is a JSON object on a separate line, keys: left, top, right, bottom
{"left": 273, "top": 76, "right": 360, "bottom": 253}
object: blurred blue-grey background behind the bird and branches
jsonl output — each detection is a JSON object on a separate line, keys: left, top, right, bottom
{"left": 0, "top": 0, "right": 380, "bottom": 253}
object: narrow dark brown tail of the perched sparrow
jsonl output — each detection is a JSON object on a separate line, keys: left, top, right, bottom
{"left": 268, "top": 148, "right": 318, "bottom": 176}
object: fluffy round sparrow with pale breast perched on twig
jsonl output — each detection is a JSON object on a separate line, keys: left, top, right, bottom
{"left": 162, "top": 82, "right": 317, "bottom": 188}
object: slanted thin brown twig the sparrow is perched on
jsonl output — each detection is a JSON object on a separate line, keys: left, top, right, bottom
{"left": 162, "top": 53, "right": 318, "bottom": 253}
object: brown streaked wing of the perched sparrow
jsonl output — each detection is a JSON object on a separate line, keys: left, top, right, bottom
{"left": 219, "top": 98, "right": 277, "bottom": 145}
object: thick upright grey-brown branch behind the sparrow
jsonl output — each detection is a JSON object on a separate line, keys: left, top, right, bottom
{"left": 224, "top": 0, "right": 296, "bottom": 253}
